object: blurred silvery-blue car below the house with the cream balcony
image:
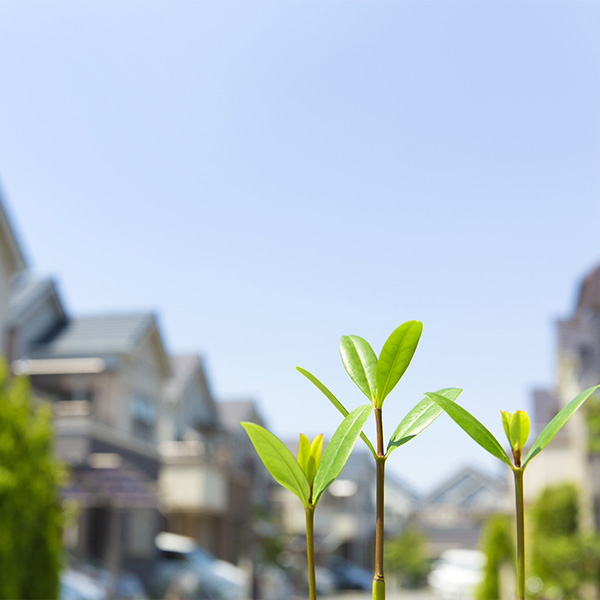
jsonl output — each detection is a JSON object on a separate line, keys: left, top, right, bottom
{"left": 154, "top": 533, "right": 250, "bottom": 600}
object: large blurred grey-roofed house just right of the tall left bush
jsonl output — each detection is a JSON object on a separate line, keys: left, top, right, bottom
{"left": 10, "top": 279, "right": 170, "bottom": 580}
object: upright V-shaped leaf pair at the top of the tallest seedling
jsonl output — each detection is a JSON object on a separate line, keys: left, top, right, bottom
{"left": 340, "top": 321, "right": 423, "bottom": 409}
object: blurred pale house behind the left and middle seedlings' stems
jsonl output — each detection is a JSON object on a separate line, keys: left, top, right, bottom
{"left": 274, "top": 450, "right": 418, "bottom": 568}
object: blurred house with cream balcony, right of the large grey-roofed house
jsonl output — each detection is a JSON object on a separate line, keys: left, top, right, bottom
{"left": 159, "top": 364, "right": 262, "bottom": 563}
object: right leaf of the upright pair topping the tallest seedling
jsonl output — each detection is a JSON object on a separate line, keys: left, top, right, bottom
{"left": 375, "top": 321, "right": 423, "bottom": 408}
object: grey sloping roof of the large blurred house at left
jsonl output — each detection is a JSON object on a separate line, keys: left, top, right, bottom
{"left": 31, "top": 313, "right": 156, "bottom": 358}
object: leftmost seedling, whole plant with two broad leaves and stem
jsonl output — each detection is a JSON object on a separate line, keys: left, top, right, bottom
{"left": 241, "top": 404, "right": 371, "bottom": 600}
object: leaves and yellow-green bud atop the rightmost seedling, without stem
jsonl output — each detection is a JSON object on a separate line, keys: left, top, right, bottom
{"left": 425, "top": 385, "right": 600, "bottom": 469}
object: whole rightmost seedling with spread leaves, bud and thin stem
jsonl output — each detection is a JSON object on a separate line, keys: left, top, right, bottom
{"left": 425, "top": 385, "right": 600, "bottom": 600}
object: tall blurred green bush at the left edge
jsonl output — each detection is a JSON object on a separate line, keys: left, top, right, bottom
{"left": 0, "top": 362, "right": 62, "bottom": 600}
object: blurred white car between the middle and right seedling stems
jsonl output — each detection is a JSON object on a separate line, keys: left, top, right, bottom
{"left": 429, "top": 549, "right": 485, "bottom": 600}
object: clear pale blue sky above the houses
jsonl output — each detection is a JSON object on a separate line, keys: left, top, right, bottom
{"left": 0, "top": 0, "right": 600, "bottom": 492}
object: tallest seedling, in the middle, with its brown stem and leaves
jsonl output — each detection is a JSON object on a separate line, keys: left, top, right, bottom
{"left": 296, "top": 321, "right": 462, "bottom": 600}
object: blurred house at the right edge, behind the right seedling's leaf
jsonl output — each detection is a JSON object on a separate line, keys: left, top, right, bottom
{"left": 525, "top": 265, "right": 600, "bottom": 528}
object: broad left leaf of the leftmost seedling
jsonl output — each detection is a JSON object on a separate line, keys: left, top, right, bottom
{"left": 241, "top": 422, "right": 310, "bottom": 506}
